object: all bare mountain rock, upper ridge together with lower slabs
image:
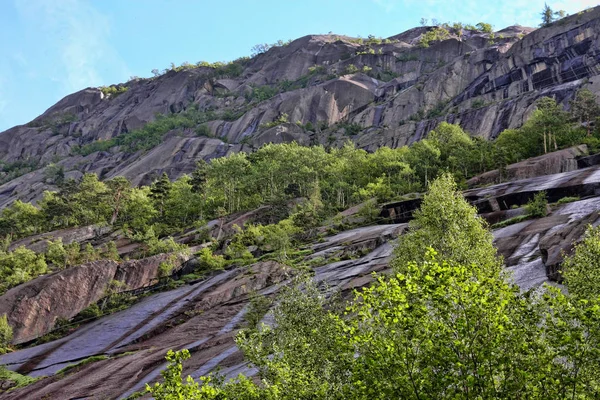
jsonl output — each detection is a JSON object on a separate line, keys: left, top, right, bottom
{"left": 0, "top": 7, "right": 600, "bottom": 399}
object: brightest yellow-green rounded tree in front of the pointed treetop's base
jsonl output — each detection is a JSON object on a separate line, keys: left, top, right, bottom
{"left": 344, "top": 252, "right": 544, "bottom": 399}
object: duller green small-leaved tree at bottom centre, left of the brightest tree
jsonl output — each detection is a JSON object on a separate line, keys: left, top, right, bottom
{"left": 236, "top": 277, "right": 354, "bottom": 399}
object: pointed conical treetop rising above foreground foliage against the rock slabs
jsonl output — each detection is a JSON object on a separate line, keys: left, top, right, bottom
{"left": 392, "top": 174, "right": 501, "bottom": 270}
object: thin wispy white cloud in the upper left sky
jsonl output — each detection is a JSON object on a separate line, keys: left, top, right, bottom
{"left": 15, "top": 0, "right": 128, "bottom": 92}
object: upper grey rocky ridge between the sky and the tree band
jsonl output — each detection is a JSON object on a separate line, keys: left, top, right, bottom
{"left": 0, "top": 8, "right": 600, "bottom": 206}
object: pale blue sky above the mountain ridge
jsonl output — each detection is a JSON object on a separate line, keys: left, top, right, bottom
{"left": 0, "top": 0, "right": 599, "bottom": 131}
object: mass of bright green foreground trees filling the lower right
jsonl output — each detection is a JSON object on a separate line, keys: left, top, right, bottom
{"left": 148, "top": 177, "right": 600, "bottom": 399}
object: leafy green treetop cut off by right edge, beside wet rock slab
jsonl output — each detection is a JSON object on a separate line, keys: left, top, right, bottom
{"left": 562, "top": 226, "right": 600, "bottom": 299}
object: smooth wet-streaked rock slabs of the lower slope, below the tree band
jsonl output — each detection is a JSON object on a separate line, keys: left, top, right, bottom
{"left": 0, "top": 149, "right": 600, "bottom": 399}
